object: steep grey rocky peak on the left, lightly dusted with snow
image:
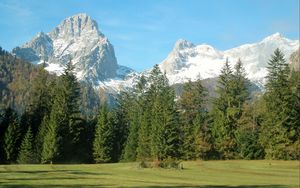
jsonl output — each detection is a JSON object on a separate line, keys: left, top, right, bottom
{"left": 12, "top": 13, "right": 134, "bottom": 86}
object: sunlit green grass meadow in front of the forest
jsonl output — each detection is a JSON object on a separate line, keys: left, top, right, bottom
{"left": 0, "top": 161, "right": 300, "bottom": 188}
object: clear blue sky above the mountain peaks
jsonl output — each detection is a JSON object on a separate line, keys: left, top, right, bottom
{"left": 0, "top": 0, "right": 299, "bottom": 71}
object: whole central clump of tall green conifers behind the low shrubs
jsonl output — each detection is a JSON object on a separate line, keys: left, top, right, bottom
{"left": 123, "top": 65, "right": 180, "bottom": 161}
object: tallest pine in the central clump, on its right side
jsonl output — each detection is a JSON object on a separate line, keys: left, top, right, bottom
{"left": 149, "top": 65, "right": 180, "bottom": 161}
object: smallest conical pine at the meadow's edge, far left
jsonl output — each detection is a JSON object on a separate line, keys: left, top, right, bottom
{"left": 17, "top": 127, "right": 36, "bottom": 164}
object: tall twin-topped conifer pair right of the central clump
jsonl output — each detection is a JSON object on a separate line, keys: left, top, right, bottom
{"left": 212, "top": 60, "right": 249, "bottom": 159}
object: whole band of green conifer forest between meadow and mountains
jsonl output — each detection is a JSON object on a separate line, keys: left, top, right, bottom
{"left": 0, "top": 49, "right": 300, "bottom": 163}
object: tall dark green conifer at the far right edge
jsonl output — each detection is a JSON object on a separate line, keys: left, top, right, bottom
{"left": 260, "top": 49, "right": 300, "bottom": 159}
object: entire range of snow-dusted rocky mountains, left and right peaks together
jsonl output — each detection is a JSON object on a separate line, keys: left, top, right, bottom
{"left": 12, "top": 13, "right": 299, "bottom": 94}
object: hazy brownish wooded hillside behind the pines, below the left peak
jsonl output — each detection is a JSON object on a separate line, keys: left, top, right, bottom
{"left": 0, "top": 47, "right": 100, "bottom": 116}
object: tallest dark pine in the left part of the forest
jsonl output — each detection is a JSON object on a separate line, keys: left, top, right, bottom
{"left": 42, "top": 61, "right": 81, "bottom": 163}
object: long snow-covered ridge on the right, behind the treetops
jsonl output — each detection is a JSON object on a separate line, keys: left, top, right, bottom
{"left": 160, "top": 33, "right": 299, "bottom": 86}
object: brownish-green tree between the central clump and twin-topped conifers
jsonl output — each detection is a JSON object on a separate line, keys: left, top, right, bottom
{"left": 179, "top": 79, "right": 210, "bottom": 160}
